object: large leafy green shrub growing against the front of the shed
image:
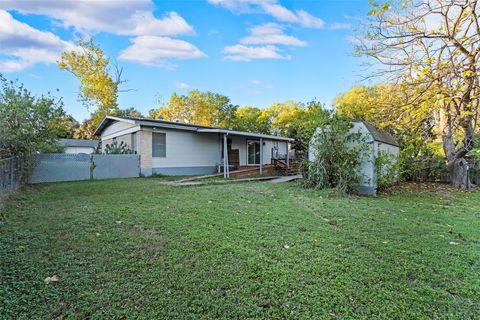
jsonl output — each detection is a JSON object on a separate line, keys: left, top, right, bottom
{"left": 302, "top": 115, "right": 368, "bottom": 193}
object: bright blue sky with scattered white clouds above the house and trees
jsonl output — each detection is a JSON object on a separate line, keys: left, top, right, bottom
{"left": 0, "top": 0, "right": 368, "bottom": 120}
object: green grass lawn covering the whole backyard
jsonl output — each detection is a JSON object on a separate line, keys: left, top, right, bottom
{"left": 0, "top": 178, "right": 480, "bottom": 319}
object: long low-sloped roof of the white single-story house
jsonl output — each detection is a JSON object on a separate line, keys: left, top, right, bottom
{"left": 94, "top": 116, "right": 294, "bottom": 141}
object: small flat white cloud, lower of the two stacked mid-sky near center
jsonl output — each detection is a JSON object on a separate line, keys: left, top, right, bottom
{"left": 223, "top": 44, "right": 291, "bottom": 61}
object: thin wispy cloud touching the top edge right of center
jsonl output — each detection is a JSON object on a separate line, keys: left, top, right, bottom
{"left": 208, "top": 0, "right": 325, "bottom": 29}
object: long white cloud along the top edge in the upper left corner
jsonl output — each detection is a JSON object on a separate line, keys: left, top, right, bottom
{"left": 0, "top": 0, "right": 195, "bottom": 36}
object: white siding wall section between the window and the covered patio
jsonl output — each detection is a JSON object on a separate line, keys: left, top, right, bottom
{"left": 151, "top": 129, "right": 221, "bottom": 168}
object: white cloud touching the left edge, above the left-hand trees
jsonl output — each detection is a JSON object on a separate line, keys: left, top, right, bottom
{"left": 0, "top": 10, "right": 76, "bottom": 72}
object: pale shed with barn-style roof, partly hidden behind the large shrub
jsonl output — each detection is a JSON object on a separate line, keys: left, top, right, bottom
{"left": 308, "top": 120, "right": 400, "bottom": 195}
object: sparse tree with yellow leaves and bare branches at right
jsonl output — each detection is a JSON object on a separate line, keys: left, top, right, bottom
{"left": 357, "top": 0, "right": 480, "bottom": 188}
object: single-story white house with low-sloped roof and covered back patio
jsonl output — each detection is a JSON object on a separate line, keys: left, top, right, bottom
{"left": 95, "top": 116, "right": 293, "bottom": 177}
